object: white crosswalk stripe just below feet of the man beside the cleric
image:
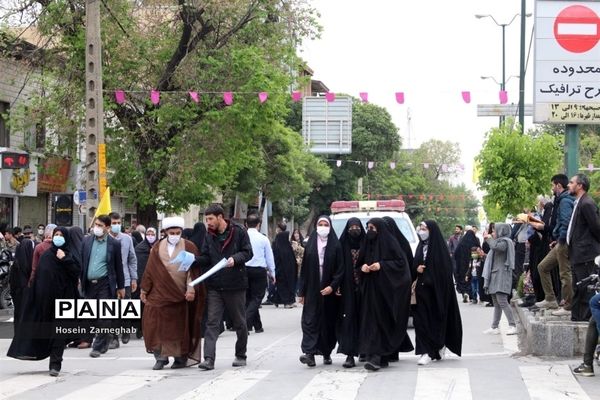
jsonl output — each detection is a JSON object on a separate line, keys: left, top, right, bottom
{"left": 176, "top": 369, "right": 271, "bottom": 400}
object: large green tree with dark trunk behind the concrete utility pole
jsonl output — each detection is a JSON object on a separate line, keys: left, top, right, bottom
{"left": 1, "top": 0, "right": 329, "bottom": 223}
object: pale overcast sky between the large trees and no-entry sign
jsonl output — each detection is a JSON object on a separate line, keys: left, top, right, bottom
{"left": 300, "top": 0, "right": 535, "bottom": 188}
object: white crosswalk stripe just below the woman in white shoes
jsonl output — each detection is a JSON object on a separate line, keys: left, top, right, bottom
{"left": 414, "top": 367, "right": 473, "bottom": 400}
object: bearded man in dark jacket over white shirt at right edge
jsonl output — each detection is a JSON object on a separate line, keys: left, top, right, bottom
{"left": 567, "top": 174, "right": 600, "bottom": 321}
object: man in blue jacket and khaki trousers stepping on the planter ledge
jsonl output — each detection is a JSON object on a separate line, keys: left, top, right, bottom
{"left": 535, "top": 174, "right": 574, "bottom": 315}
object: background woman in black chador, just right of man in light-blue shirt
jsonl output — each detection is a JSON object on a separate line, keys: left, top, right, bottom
{"left": 273, "top": 231, "right": 296, "bottom": 308}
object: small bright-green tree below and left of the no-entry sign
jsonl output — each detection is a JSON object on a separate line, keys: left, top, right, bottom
{"left": 477, "top": 124, "right": 562, "bottom": 221}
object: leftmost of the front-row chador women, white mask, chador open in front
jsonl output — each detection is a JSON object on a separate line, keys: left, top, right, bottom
{"left": 298, "top": 216, "right": 344, "bottom": 367}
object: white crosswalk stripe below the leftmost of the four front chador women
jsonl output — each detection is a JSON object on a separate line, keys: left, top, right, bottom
{"left": 294, "top": 371, "right": 367, "bottom": 400}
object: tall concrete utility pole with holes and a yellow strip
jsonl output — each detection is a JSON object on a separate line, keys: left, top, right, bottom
{"left": 85, "top": 0, "right": 106, "bottom": 220}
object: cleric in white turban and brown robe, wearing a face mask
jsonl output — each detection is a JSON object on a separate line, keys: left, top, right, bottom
{"left": 140, "top": 217, "right": 206, "bottom": 370}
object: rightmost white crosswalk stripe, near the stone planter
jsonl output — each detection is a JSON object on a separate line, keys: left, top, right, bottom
{"left": 519, "top": 365, "right": 590, "bottom": 400}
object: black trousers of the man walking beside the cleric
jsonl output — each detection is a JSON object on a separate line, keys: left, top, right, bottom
{"left": 204, "top": 289, "right": 248, "bottom": 361}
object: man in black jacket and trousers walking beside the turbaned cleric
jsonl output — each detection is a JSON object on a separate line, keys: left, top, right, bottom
{"left": 197, "top": 204, "right": 252, "bottom": 370}
